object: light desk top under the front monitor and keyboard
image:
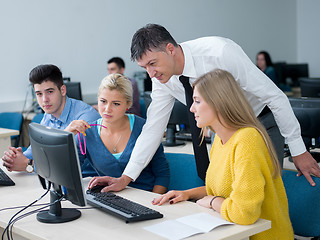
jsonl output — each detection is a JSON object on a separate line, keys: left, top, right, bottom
{"left": 0, "top": 167, "right": 271, "bottom": 240}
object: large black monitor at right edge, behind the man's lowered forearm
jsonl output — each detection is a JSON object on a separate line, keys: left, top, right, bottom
{"left": 289, "top": 98, "right": 320, "bottom": 162}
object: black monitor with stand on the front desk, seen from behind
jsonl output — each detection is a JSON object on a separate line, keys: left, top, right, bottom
{"left": 29, "top": 123, "right": 86, "bottom": 223}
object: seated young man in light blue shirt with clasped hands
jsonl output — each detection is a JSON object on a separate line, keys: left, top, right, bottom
{"left": 2, "top": 64, "right": 100, "bottom": 172}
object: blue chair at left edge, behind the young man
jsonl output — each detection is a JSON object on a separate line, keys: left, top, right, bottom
{"left": 0, "top": 112, "right": 23, "bottom": 147}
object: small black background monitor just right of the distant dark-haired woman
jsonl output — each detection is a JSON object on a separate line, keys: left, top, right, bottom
{"left": 284, "top": 63, "right": 309, "bottom": 86}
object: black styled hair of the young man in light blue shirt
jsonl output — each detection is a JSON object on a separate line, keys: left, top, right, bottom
{"left": 29, "top": 64, "right": 63, "bottom": 89}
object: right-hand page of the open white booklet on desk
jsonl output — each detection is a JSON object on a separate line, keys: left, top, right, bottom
{"left": 176, "top": 213, "right": 234, "bottom": 232}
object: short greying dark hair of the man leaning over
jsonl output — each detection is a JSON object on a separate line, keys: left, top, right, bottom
{"left": 131, "top": 24, "right": 178, "bottom": 61}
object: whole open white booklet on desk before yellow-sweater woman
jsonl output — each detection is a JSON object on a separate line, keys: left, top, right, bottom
{"left": 144, "top": 213, "right": 234, "bottom": 240}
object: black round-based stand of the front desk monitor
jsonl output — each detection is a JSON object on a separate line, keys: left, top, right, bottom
{"left": 37, "top": 187, "right": 81, "bottom": 223}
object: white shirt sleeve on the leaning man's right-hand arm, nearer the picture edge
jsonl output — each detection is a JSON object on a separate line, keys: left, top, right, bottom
{"left": 223, "top": 42, "right": 306, "bottom": 156}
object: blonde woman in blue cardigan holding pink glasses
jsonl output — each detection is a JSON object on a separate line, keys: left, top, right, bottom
{"left": 76, "top": 73, "right": 170, "bottom": 193}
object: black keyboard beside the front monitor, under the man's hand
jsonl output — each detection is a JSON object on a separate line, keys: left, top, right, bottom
{"left": 86, "top": 190, "right": 163, "bottom": 223}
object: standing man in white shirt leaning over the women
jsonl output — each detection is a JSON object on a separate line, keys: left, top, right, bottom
{"left": 99, "top": 24, "right": 320, "bottom": 191}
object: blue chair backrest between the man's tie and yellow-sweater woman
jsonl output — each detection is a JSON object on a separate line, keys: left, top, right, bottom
{"left": 165, "top": 153, "right": 204, "bottom": 190}
